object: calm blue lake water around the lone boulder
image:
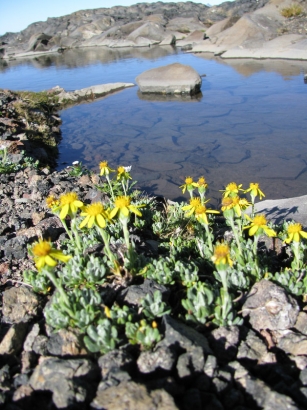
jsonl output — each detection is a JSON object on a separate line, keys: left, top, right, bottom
{"left": 0, "top": 47, "right": 307, "bottom": 205}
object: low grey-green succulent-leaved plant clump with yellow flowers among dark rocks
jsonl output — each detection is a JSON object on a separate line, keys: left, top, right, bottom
{"left": 24, "top": 161, "right": 307, "bottom": 353}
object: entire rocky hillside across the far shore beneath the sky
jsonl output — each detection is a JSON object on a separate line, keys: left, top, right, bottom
{"left": 0, "top": 0, "right": 307, "bottom": 59}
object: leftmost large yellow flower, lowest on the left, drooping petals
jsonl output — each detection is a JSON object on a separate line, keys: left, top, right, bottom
{"left": 32, "top": 240, "right": 72, "bottom": 270}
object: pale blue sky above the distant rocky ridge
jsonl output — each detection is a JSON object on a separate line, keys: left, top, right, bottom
{"left": 0, "top": 0, "right": 230, "bottom": 35}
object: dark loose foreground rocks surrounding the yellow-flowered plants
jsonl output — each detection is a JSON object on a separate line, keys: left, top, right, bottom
{"left": 0, "top": 91, "right": 307, "bottom": 410}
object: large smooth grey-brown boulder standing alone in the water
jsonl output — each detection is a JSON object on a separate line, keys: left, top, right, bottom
{"left": 136, "top": 63, "right": 201, "bottom": 94}
